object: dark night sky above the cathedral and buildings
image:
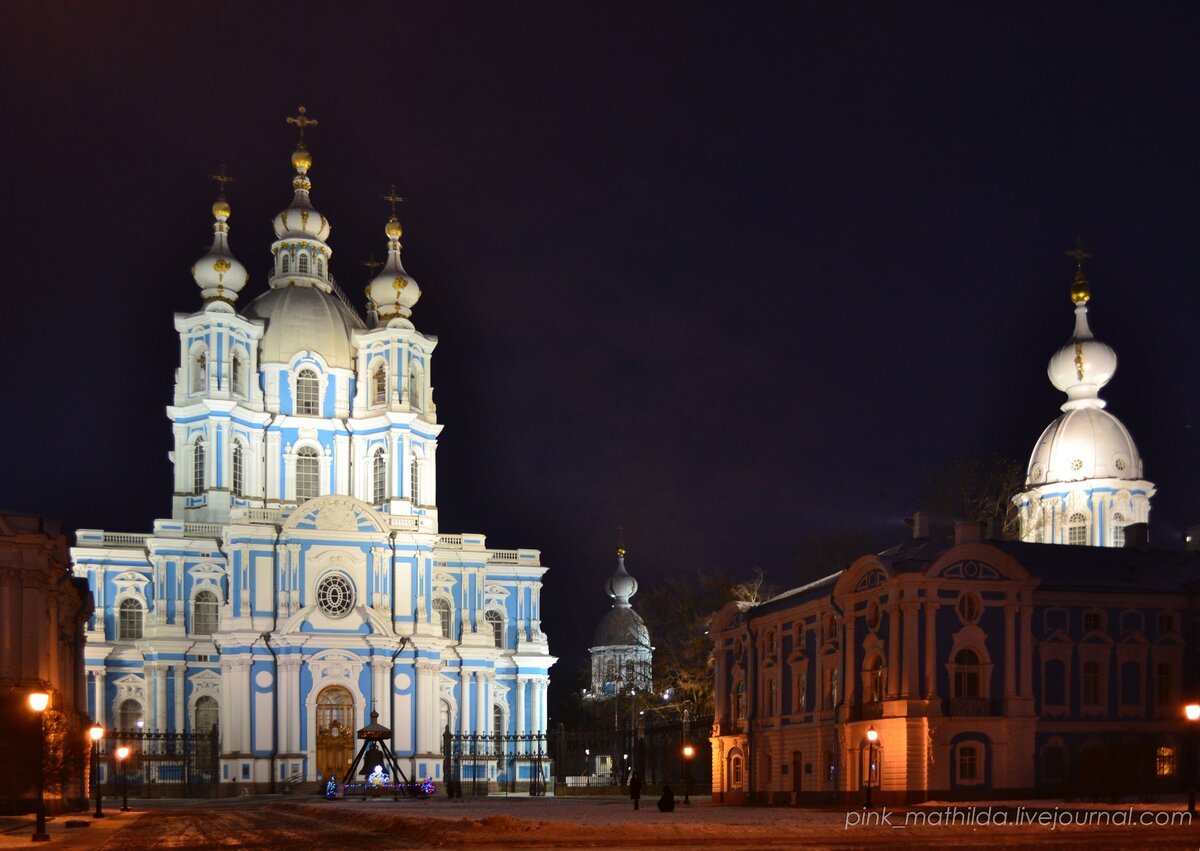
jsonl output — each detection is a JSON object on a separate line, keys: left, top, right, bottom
{"left": 0, "top": 2, "right": 1200, "bottom": 705}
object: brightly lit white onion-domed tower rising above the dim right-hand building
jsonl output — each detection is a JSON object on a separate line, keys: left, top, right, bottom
{"left": 1013, "top": 244, "right": 1154, "bottom": 546}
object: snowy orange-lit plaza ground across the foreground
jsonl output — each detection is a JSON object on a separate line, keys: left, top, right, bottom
{"left": 0, "top": 796, "right": 1200, "bottom": 851}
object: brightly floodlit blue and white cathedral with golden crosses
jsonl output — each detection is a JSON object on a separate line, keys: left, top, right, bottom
{"left": 72, "top": 108, "right": 556, "bottom": 784}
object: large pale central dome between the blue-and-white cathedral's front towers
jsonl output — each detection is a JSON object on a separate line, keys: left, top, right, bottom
{"left": 238, "top": 286, "right": 366, "bottom": 370}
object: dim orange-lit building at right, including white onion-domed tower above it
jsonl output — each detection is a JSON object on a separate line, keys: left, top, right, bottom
{"left": 709, "top": 252, "right": 1200, "bottom": 805}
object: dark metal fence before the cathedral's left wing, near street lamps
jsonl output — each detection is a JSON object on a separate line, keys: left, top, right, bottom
{"left": 96, "top": 730, "right": 221, "bottom": 798}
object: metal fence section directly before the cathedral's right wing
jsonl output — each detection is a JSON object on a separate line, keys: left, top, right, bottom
{"left": 442, "top": 730, "right": 552, "bottom": 797}
